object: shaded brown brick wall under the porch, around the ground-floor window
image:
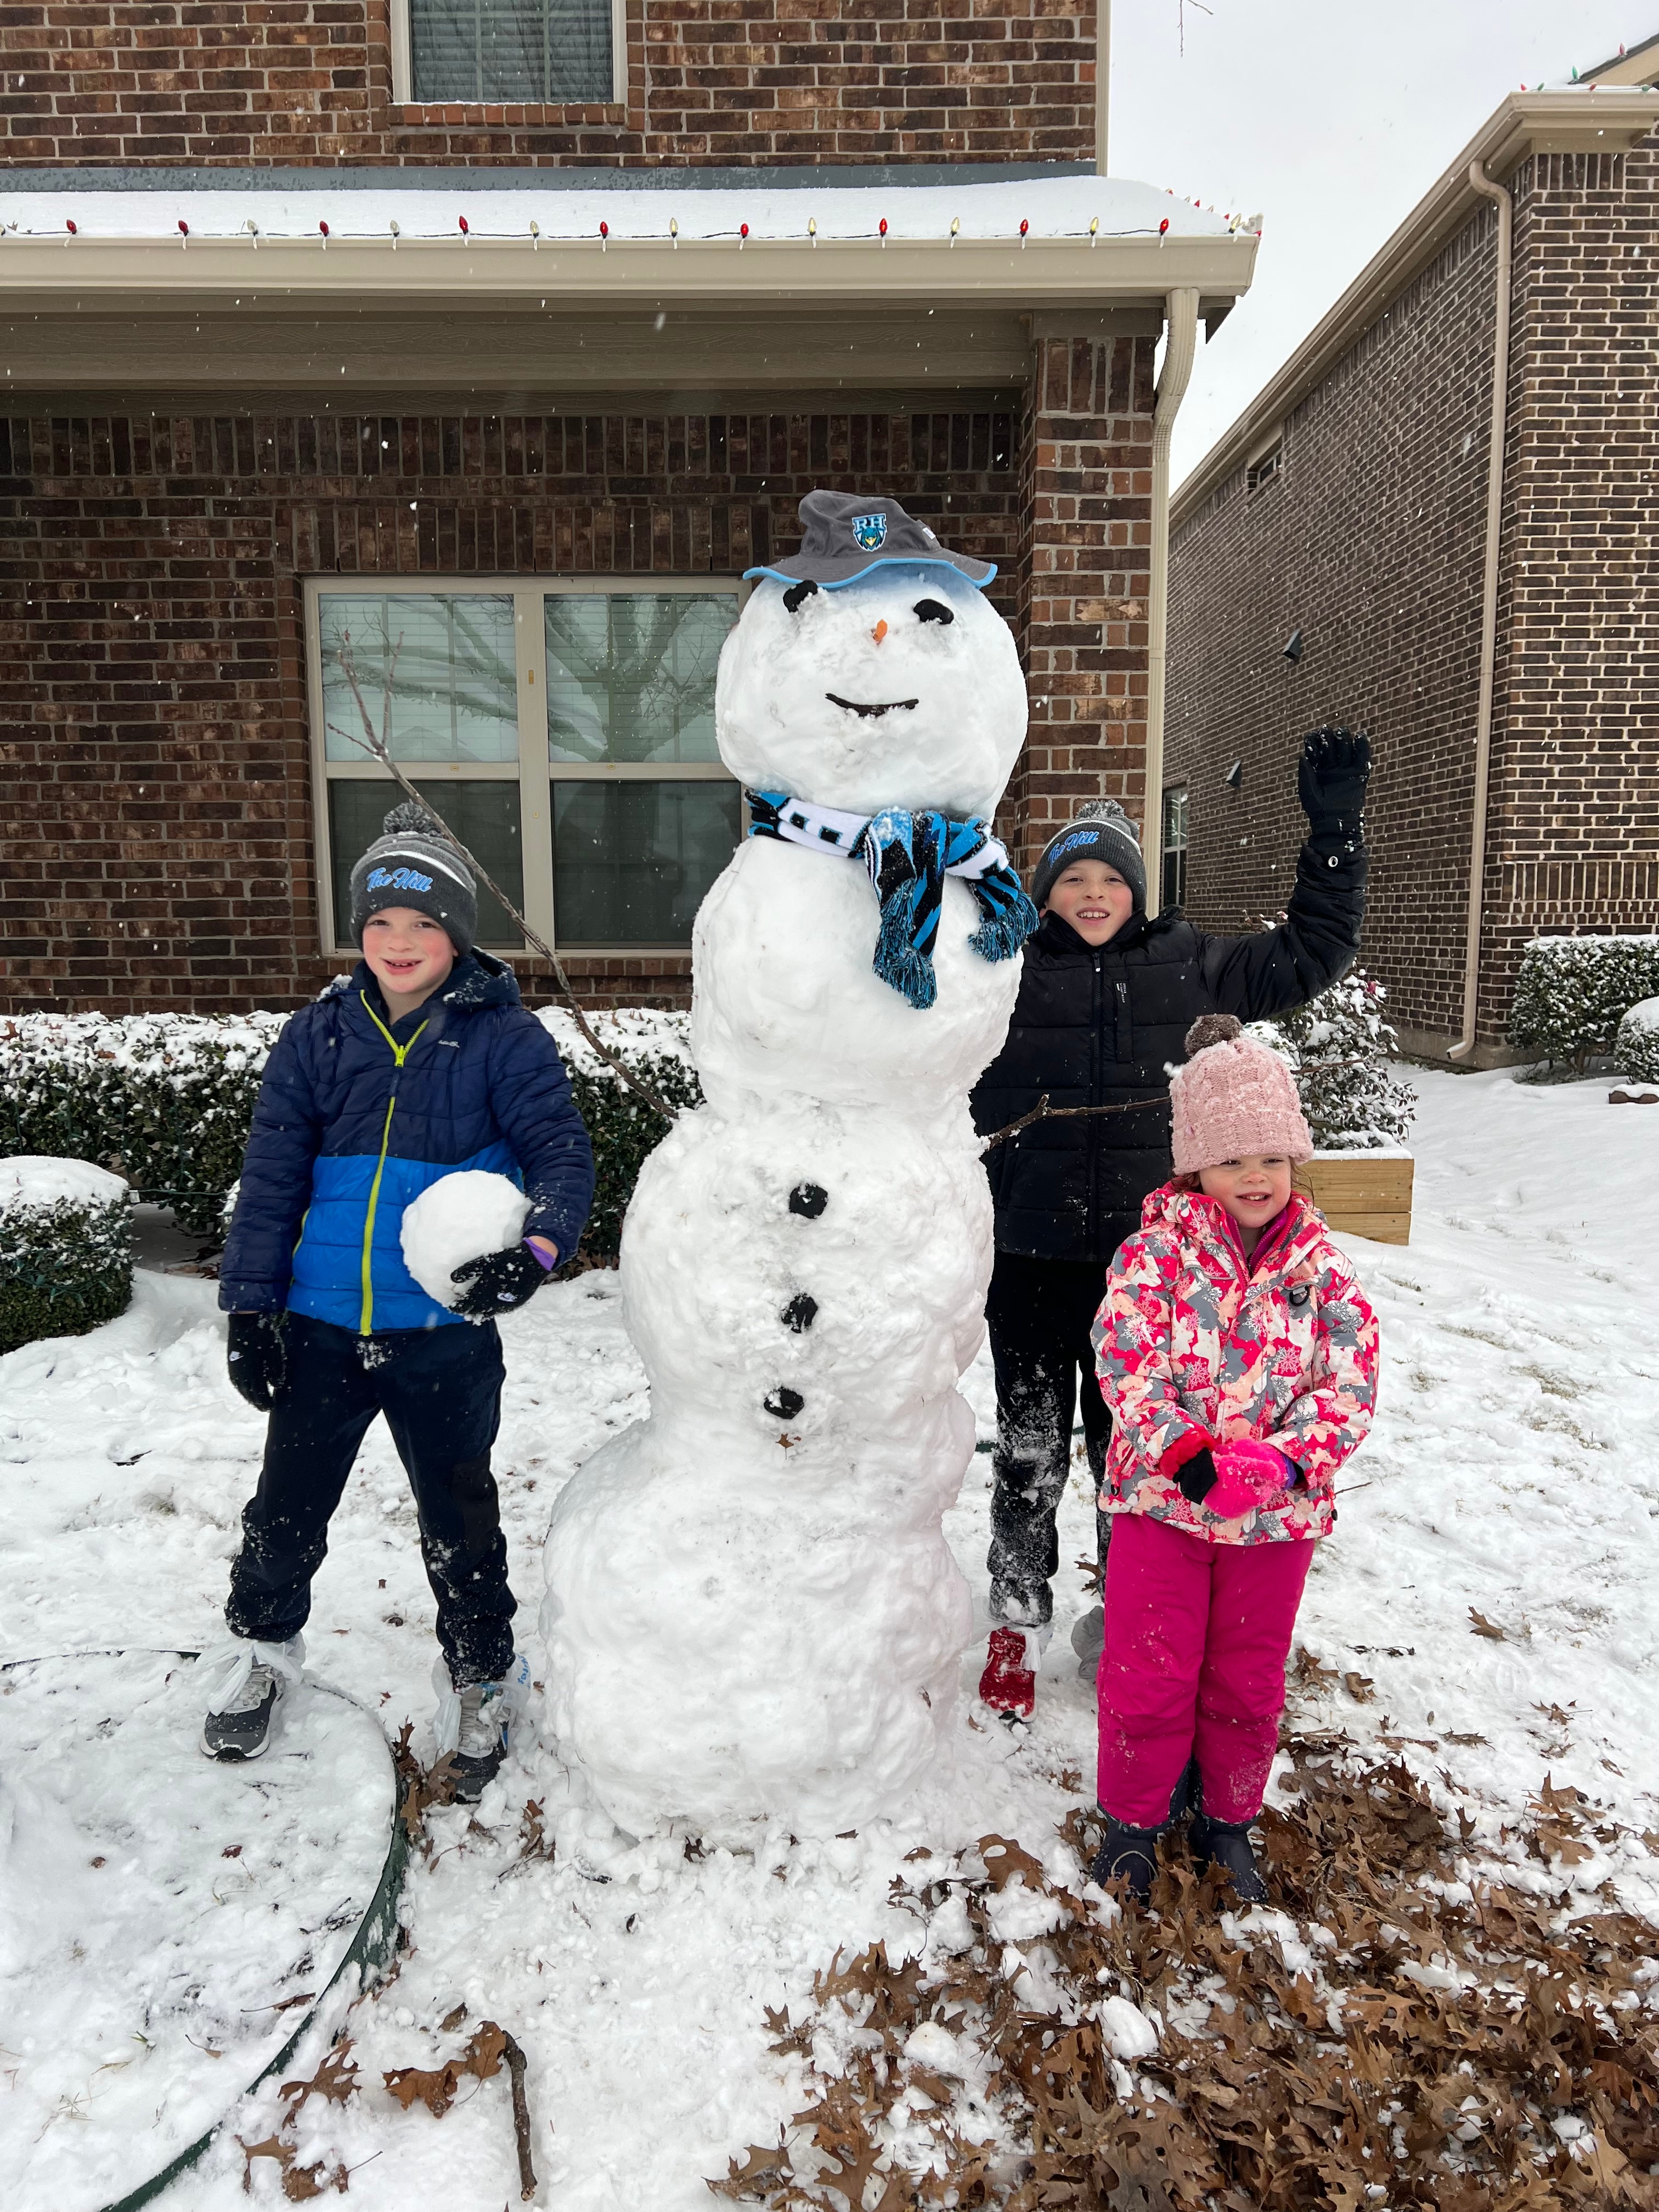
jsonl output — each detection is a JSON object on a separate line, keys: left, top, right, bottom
{"left": 0, "top": 409, "right": 1020, "bottom": 1013}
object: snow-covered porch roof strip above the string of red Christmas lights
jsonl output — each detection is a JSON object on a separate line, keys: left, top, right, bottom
{"left": 0, "top": 168, "right": 1261, "bottom": 249}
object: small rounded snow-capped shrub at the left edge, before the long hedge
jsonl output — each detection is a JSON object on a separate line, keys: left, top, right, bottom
{"left": 0, "top": 1157, "right": 133, "bottom": 1352}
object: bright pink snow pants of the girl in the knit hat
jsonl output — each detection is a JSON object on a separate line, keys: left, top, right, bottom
{"left": 1097, "top": 1513, "right": 1314, "bottom": 1827}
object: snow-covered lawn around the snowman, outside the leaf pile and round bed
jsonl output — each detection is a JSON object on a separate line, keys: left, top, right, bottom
{"left": 0, "top": 1073, "right": 1659, "bottom": 2212}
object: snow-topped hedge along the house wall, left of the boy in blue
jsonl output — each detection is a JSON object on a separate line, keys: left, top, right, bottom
{"left": 0, "top": 1013, "right": 287, "bottom": 1237}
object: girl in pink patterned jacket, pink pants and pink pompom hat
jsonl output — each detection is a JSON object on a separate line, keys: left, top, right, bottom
{"left": 1095, "top": 1015, "right": 1378, "bottom": 1903}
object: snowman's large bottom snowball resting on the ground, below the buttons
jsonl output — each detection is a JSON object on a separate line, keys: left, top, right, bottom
{"left": 542, "top": 1420, "right": 971, "bottom": 1836}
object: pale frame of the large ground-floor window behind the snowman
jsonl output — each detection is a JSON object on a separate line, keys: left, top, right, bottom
{"left": 305, "top": 573, "right": 754, "bottom": 960}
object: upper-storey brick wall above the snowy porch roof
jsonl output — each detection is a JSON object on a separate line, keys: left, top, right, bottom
{"left": 0, "top": 0, "right": 1095, "bottom": 168}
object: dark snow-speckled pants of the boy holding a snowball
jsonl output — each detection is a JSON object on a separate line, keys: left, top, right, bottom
{"left": 225, "top": 1314, "right": 517, "bottom": 1688}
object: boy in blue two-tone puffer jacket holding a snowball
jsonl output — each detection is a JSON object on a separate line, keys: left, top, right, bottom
{"left": 201, "top": 803, "right": 593, "bottom": 1801}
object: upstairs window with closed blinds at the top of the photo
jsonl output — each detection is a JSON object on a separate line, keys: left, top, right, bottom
{"left": 405, "top": 0, "right": 615, "bottom": 106}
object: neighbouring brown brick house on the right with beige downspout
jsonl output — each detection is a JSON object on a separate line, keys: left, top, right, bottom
{"left": 1164, "top": 64, "right": 1659, "bottom": 1064}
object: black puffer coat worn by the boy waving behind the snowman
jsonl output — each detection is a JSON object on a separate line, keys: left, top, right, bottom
{"left": 973, "top": 845, "right": 1365, "bottom": 1267}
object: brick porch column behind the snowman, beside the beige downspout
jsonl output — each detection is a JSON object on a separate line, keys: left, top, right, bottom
{"left": 1005, "top": 329, "right": 1157, "bottom": 870}
